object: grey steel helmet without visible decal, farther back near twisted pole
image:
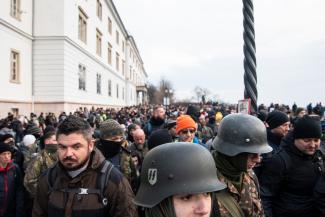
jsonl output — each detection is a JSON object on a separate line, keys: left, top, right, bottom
{"left": 213, "top": 114, "right": 272, "bottom": 156}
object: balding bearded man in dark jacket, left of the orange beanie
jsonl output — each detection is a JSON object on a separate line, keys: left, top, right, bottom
{"left": 144, "top": 106, "right": 166, "bottom": 137}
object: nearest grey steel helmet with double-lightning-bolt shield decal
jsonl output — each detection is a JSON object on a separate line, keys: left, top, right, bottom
{"left": 134, "top": 142, "right": 226, "bottom": 208}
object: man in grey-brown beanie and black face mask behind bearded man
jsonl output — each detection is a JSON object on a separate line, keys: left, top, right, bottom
{"left": 96, "top": 119, "right": 137, "bottom": 192}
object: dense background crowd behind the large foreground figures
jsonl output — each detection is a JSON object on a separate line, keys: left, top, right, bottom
{"left": 0, "top": 103, "right": 325, "bottom": 217}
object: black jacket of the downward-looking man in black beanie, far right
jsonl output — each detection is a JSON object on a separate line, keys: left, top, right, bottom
{"left": 259, "top": 133, "right": 320, "bottom": 217}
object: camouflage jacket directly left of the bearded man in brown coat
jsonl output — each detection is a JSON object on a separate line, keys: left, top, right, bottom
{"left": 24, "top": 149, "right": 58, "bottom": 198}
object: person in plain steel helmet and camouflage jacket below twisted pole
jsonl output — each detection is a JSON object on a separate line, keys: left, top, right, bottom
{"left": 213, "top": 114, "right": 272, "bottom": 217}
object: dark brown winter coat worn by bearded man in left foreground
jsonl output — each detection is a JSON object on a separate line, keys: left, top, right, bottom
{"left": 33, "top": 149, "right": 137, "bottom": 217}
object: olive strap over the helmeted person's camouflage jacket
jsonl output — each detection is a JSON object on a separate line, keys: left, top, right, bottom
{"left": 216, "top": 189, "right": 245, "bottom": 217}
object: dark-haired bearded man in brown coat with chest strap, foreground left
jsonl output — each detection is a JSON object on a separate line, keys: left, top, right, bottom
{"left": 33, "top": 116, "right": 137, "bottom": 217}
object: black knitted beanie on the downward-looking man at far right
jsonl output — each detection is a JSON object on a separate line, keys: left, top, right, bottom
{"left": 293, "top": 115, "right": 322, "bottom": 139}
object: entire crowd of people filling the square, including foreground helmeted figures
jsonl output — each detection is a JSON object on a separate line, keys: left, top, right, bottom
{"left": 0, "top": 103, "right": 325, "bottom": 217}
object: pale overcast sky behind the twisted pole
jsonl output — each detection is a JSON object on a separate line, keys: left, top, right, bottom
{"left": 114, "top": 0, "right": 325, "bottom": 106}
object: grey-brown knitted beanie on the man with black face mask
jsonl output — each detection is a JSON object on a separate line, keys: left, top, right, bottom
{"left": 99, "top": 119, "right": 124, "bottom": 139}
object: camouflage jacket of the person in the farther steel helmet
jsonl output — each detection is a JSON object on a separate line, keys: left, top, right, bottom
{"left": 218, "top": 171, "right": 265, "bottom": 217}
